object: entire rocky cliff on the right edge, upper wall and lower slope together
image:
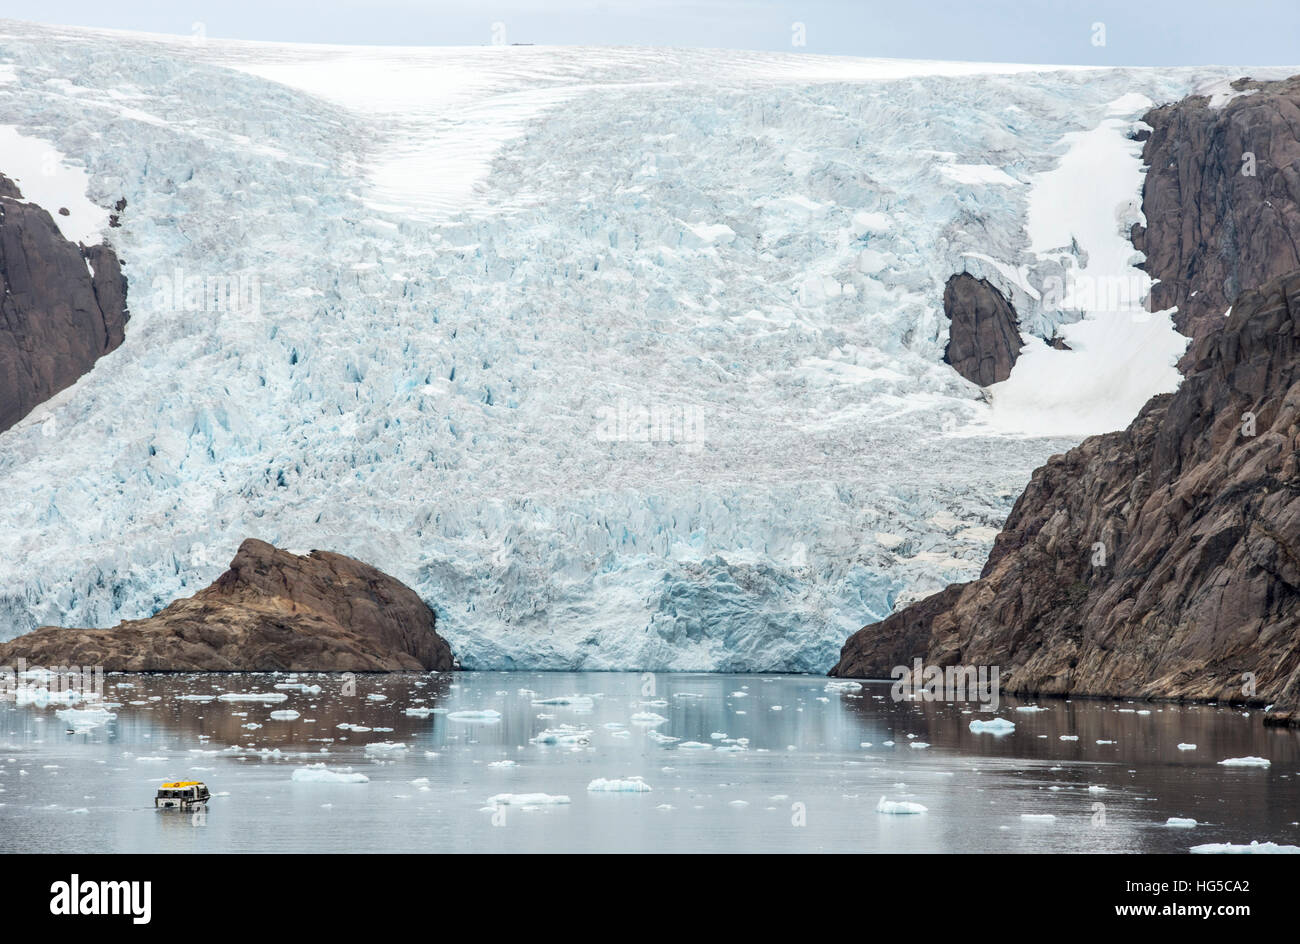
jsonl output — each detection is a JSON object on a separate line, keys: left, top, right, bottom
{"left": 831, "top": 79, "right": 1300, "bottom": 723}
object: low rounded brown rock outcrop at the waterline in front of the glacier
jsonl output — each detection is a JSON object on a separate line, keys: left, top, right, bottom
{"left": 0, "top": 540, "right": 452, "bottom": 672}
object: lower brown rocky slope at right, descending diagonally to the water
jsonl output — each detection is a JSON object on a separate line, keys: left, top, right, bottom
{"left": 832, "top": 272, "right": 1300, "bottom": 713}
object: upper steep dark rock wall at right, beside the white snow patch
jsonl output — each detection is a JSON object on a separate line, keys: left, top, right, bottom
{"left": 1132, "top": 77, "right": 1300, "bottom": 348}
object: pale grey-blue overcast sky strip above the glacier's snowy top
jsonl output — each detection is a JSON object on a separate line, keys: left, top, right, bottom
{"left": 0, "top": 0, "right": 1300, "bottom": 65}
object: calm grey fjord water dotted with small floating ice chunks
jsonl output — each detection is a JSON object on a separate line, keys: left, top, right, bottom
{"left": 0, "top": 672, "right": 1300, "bottom": 853}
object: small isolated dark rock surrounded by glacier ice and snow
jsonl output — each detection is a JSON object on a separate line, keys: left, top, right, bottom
{"left": 944, "top": 272, "right": 1021, "bottom": 386}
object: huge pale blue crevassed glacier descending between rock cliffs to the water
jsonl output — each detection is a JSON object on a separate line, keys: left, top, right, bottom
{"left": 0, "top": 23, "right": 1279, "bottom": 670}
